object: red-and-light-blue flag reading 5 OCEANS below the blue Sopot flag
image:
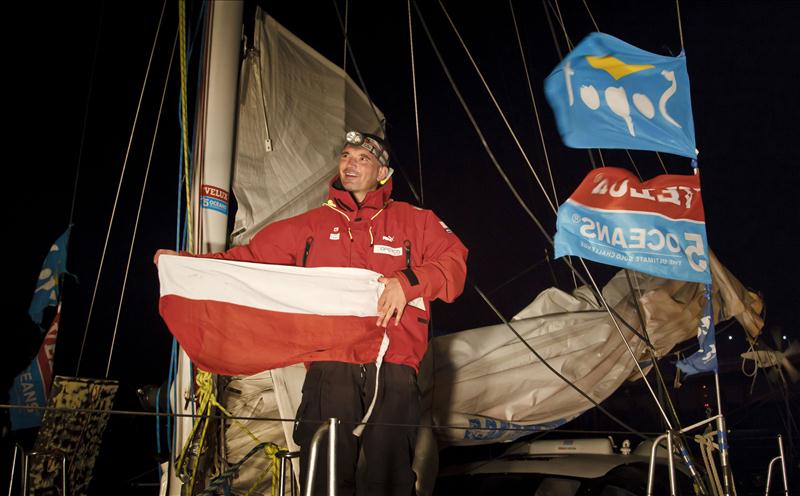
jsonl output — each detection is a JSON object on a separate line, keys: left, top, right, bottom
{"left": 555, "top": 167, "right": 711, "bottom": 284}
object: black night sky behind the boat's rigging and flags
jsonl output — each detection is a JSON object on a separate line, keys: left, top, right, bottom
{"left": 4, "top": 0, "right": 800, "bottom": 492}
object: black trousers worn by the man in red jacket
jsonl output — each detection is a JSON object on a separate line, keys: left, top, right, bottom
{"left": 294, "top": 362, "right": 420, "bottom": 496}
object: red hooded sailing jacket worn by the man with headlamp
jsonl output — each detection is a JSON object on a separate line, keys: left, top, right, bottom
{"left": 202, "top": 176, "right": 467, "bottom": 370}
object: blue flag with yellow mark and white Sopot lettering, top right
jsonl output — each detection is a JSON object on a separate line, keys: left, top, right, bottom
{"left": 545, "top": 33, "right": 697, "bottom": 158}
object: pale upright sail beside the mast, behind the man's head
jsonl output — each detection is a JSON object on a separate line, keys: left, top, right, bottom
{"left": 233, "top": 9, "right": 383, "bottom": 245}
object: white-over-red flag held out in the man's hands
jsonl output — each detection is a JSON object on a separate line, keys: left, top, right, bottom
{"left": 158, "top": 255, "right": 383, "bottom": 375}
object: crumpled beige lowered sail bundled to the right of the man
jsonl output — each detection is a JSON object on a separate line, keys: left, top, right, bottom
{"left": 420, "top": 254, "right": 763, "bottom": 447}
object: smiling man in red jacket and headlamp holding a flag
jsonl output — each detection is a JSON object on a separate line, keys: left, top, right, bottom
{"left": 155, "top": 131, "right": 467, "bottom": 496}
